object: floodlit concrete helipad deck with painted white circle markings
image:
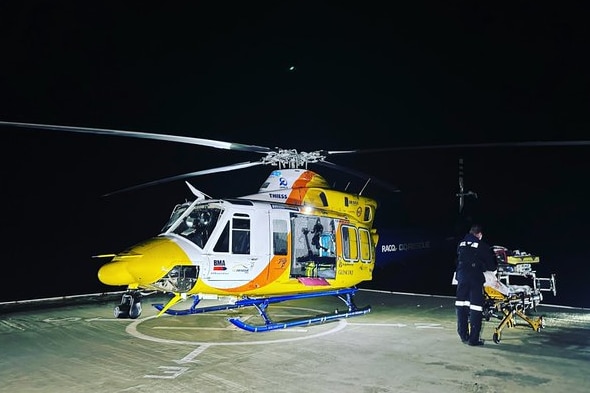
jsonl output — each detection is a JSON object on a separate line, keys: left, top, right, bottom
{"left": 0, "top": 290, "right": 590, "bottom": 393}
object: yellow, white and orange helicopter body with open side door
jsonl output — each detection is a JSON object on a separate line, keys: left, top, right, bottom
{"left": 98, "top": 169, "right": 378, "bottom": 297}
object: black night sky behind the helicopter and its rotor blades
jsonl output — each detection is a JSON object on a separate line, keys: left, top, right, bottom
{"left": 0, "top": 1, "right": 590, "bottom": 307}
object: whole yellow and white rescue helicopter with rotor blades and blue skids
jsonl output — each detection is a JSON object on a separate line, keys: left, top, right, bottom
{"left": 0, "top": 121, "right": 590, "bottom": 332}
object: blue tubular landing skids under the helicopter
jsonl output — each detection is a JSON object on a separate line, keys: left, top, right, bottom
{"left": 153, "top": 288, "right": 371, "bottom": 333}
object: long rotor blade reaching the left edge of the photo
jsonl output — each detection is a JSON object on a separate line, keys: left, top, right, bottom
{"left": 0, "top": 121, "right": 273, "bottom": 153}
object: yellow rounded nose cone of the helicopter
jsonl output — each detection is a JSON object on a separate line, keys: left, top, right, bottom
{"left": 98, "top": 237, "right": 192, "bottom": 288}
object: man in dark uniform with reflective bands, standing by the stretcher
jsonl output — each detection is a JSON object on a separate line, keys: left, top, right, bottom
{"left": 455, "top": 224, "right": 497, "bottom": 346}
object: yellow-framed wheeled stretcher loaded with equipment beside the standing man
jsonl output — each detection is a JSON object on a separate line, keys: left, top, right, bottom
{"left": 483, "top": 246, "right": 557, "bottom": 344}
